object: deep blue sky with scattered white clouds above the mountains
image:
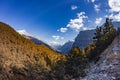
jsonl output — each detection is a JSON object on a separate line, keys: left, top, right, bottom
{"left": 0, "top": 0, "right": 120, "bottom": 44}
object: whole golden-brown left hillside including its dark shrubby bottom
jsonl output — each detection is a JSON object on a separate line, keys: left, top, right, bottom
{"left": 0, "top": 22, "right": 65, "bottom": 80}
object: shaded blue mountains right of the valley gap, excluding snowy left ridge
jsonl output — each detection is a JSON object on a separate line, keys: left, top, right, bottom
{"left": 57, "top": 21, "right": 120, "bottom": 54}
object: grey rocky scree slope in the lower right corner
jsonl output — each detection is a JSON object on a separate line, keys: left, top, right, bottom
{"left": 80, "top": 36, "right": 120, "bottom": 80}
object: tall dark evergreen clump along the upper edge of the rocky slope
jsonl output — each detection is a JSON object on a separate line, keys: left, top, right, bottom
{"left": 89, "top": 18, "right": 117, "bottom": 60}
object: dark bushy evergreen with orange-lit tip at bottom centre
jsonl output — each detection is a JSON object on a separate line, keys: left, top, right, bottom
{"left": 65, "top": 46, "right": 87, "bottom": 79}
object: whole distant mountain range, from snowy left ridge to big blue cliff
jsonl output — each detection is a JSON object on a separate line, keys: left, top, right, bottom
{"left": 17, "top": 22, "right": 120, "bottom": 54}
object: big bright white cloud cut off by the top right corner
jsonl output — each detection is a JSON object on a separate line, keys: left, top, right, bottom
{"left": 108, "top": 0, "right": 120, "bottom": 12}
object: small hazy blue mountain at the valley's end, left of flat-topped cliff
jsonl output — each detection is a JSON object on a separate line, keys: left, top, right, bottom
{"left": 58, "top": 41, "right": 74, "bottom": 54}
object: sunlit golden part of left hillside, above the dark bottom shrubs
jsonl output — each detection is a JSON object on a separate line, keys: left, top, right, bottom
{"left": 0, "top": 22, "right": 65, "bottom": 80}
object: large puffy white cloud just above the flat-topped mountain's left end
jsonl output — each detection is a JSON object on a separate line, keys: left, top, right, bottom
{"left": 67, "top": 12, "right": 88, "bottom": 31}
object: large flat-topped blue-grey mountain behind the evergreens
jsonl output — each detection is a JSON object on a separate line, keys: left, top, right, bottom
{"left": 73, "top": 30, "right": 95, "bottom": 49}
